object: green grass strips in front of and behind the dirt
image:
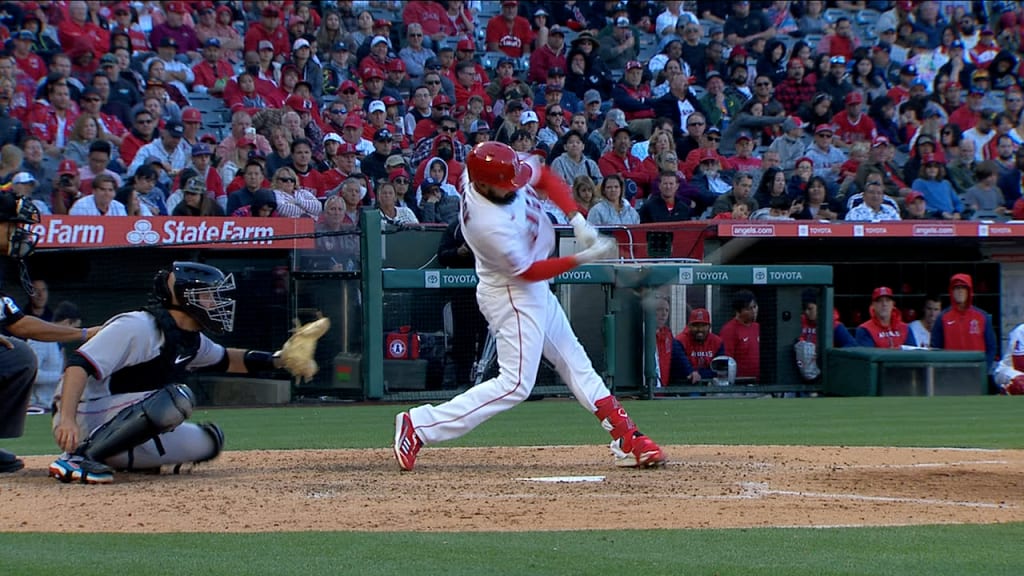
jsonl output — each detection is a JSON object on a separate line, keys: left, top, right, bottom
{"left": 0, "top": 397, "right": 1024, "bottom": 576}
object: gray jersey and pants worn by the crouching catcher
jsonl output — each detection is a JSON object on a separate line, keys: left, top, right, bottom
{"left": 53, "top": 311, "right": 226, "bottom": 469}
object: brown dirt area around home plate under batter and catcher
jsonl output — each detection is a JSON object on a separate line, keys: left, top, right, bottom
{"left": 0, "top": 446, "right": 1024, "bottom": 532}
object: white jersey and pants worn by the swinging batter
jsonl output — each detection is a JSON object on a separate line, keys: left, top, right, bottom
{"left": 409, "top": 169, "right": 610, "bottom": 444}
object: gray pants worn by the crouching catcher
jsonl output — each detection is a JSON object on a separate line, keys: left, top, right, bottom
{"left": 53, "top": 390, "right": 216, "bottom": 469}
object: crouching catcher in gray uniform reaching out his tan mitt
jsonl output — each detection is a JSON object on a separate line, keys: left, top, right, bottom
{"left": 49, "top": 262, "right": 328, "bottom": 484}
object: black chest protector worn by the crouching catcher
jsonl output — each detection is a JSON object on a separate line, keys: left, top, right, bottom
{"left": 111, "top": 307, "right": 200, "bottom": 394}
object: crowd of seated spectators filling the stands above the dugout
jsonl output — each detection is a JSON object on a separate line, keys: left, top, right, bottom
{"left": 0, "top": 0, "right": 1024, "bottom": 222}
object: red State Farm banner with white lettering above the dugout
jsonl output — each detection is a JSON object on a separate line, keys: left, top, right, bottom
{"left": 33, "top": 216, "right": 313, "bottom": 250}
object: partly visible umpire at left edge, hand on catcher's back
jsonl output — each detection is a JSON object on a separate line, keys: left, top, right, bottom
{"left": 0, "top": 193, "right": 99, "bottom": 474}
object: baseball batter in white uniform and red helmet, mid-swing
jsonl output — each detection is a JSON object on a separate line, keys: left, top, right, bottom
{"left": 394, "top": 141, "right": 666, "bottom": 470}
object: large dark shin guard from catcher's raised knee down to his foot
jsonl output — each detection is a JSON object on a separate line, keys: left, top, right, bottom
{"left": 76, "top": 384, "right": 196, "bottom": 462}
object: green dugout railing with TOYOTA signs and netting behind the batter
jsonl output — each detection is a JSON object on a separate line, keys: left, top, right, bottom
{"left": 313, "top": 210, "right": 833, "bottom": 402}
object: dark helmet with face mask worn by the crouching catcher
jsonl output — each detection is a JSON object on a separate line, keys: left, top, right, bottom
{"left": 153, "top": 262, "right": 234, "bottom": 334}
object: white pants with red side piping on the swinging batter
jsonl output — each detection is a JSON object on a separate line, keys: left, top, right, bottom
{"left": 409, "top": 282, "right": 610, "bottom": 444}
